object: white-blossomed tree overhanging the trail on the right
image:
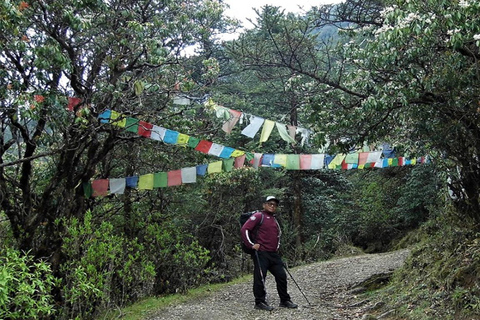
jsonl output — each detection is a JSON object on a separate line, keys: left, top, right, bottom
{"left": 227, "top": 0, "right": 480, "bottom": 223}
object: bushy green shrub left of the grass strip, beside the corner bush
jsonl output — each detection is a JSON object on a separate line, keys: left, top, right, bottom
{"left": 61, "top": 212, "right": 155, "bottom": 318}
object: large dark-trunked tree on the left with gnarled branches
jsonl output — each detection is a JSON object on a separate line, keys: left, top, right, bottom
{"left": 0, "top": 0, "right": 232, "bottom": 284}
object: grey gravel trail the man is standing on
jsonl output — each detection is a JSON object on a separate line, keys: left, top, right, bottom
{"left": 149, "top": 250, "right": 409, "bottom": 320}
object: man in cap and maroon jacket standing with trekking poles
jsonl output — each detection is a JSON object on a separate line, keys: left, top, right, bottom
{"left": 242, "top": 196, "right": 298, "bottom": 311}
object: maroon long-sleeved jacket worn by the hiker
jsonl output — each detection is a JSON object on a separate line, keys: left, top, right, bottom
{"left": 241, "top": 211, "right": 281, "bottom": 252}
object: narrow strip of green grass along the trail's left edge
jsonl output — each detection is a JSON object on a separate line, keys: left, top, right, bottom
{"left": 97, "top": 275, "right": 251, "bottom": 320}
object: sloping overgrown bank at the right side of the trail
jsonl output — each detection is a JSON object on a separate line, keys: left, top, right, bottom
{"left": 370, "top": 209, "right": 480, "bottom": 320}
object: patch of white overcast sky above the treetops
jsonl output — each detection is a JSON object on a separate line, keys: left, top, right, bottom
{"left": 225, "top": 0, "right": 342, "bottom": 28}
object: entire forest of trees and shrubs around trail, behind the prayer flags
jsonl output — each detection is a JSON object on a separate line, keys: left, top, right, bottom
{"left": 0, "top": 0, "right": 480, "bottom": 319}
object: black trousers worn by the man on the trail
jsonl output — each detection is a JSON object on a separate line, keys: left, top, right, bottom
{"left": 252, "top": 251, "right": 290, "bottom": 303}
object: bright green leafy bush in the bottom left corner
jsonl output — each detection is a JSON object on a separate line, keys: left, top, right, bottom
{"left": 0, "top": 247, "right": 56, "bottom": 320}
